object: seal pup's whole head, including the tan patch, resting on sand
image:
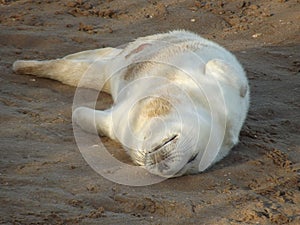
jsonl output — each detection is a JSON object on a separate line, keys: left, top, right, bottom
{"left": 124, "top": 97, "right": 206, "bottom": 177}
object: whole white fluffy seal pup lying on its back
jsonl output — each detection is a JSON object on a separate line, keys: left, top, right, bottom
{"left": 13, "top": 31, "right": 249, "bottom": 177}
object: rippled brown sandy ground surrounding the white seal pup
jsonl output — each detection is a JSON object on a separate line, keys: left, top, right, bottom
{"left": 0, "top": 0, "right": 300, "bottom": 225}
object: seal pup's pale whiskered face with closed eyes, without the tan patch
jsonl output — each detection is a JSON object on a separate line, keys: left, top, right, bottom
{"left": 130, "top": 103, "right": 199, "bottom": 177}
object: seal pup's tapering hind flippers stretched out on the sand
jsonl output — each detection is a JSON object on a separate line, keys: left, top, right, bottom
{"left": 13, "top": 48, "right": 122, "bottom": 92}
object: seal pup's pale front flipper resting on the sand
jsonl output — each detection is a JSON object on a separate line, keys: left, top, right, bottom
{"left": 73, "top": 107, "right": 116, "bottom": 139}
